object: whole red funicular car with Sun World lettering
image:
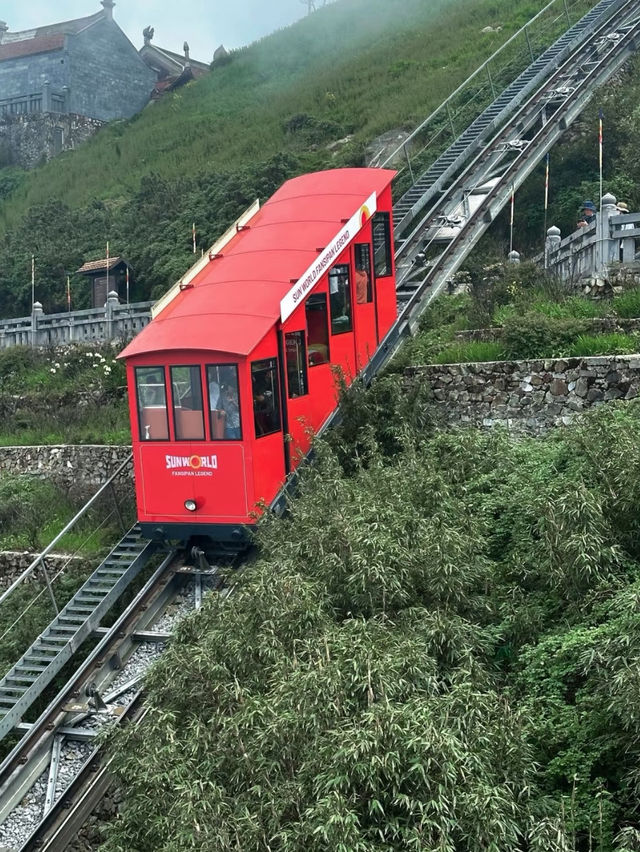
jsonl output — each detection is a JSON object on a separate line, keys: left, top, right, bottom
{"left": 120, "top": 169, "right": 396, "bottom": 543}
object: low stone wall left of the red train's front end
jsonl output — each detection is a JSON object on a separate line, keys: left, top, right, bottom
{"left": 0, "top": 444, "right": 131, "bottom": 486}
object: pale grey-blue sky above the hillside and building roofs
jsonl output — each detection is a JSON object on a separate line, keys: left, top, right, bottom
{"left": 0, "top": 0, "right": 320, "bottom": 62}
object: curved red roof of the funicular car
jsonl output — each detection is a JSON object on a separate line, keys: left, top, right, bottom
{"left": 121, "top": 169, "right": 395, "bottom": 358}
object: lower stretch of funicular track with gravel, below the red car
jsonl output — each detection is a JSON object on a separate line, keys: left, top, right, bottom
{"left": 0, "top": 551, "right": 228, "bottom": 852}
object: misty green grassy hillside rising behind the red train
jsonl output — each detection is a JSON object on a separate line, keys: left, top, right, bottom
{"left": 0, "top": 0, "right": 576, "bottom": 316}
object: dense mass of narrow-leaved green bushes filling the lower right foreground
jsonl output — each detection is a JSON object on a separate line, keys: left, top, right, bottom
{"left": 104, "top": 386, "right": 640, "bottom": 852}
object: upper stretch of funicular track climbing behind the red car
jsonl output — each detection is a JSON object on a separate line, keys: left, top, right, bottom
{"left": 363, "top": 0, "right": 640, "bottom": 381}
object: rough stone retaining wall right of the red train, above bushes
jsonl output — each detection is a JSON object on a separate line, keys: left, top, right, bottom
{"left": 405, "top": 355, "right": 640, "bottom": 434}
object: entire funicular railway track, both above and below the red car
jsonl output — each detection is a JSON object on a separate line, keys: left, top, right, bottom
{"left": 0, "top": 0, "right": 640, "bottom": 852}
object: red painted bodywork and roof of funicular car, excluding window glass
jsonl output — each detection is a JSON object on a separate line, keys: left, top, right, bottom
{"left": 121, "top": 169, "right": 396, "bottom": 540}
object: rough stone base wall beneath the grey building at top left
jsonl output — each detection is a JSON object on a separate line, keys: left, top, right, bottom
{"left": 0, "top": 112, "right": 104, "bottom": 169}
